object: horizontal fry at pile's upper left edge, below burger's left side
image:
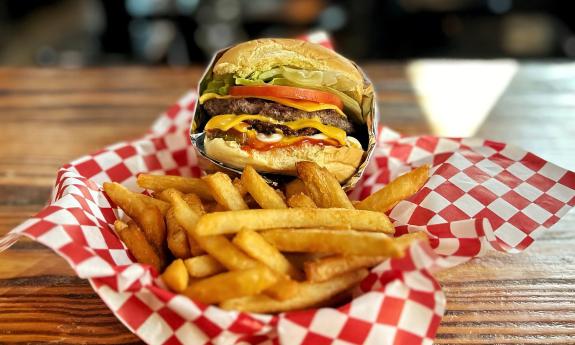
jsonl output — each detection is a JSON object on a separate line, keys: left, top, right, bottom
{"left": 137, "top": 174, "right": 214, "bottom": 200}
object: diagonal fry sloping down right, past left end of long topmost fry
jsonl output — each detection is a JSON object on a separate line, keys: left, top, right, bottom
{"left": 172, "top": 189, "right": 257, "bottom": 270}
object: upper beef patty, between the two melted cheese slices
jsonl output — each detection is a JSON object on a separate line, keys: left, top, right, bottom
{"left": 203, "top": 98, "right": 353, "bottom": 135}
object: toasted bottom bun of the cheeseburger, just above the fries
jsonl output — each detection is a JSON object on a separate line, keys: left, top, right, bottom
{"left": 204, "top": 138, "right": 364, "bottom": 182}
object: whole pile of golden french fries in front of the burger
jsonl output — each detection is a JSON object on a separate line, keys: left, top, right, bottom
{"left": 104, "top": 162, "right": 429, "bottom": 313}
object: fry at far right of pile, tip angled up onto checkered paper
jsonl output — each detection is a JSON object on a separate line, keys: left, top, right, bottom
{"left": 355, "top": 165, "right": 429, "bottom": 212}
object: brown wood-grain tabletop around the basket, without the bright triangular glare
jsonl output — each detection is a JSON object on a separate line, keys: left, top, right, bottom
{"left": 0, "top": 62, "right": 575, "bottom": 344}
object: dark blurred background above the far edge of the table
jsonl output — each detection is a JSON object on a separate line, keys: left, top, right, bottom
{"left": 0, "top": 0, "right": 575, "bottom": 67}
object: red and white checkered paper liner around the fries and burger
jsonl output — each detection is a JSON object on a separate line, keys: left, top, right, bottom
{"left": 0, "top": 32, "right": 575, "bottom": 345}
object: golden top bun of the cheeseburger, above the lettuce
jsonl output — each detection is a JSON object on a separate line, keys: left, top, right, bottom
{"left": 213, "top": 38, "right": 364, "bottom": 102}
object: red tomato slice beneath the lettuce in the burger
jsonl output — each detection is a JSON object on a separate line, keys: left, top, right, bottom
{"left": 230, "top": 85, "right": 343, "bottom": 110}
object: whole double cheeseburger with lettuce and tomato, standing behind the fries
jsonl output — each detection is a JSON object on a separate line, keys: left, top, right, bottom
{"left": 195, "top": 39, "right": 373, "bottom": 182}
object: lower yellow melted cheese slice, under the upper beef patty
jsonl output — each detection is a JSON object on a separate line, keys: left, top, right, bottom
{"left": 205, "top": 114, "right": 347, "bottom": 145}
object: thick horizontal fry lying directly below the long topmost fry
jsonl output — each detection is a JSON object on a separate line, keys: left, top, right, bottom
{"left": 261, "top": 229, "right": 402, "bottom": 257}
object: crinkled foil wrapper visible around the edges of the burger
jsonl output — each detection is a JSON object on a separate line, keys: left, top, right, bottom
{"left": 190, "top": 48, "right": 378, "bottom": 190}
